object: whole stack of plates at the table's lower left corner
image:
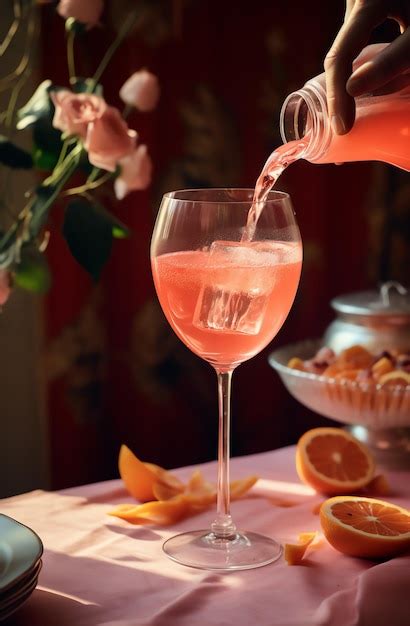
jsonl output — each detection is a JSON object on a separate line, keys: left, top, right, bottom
{"left": 0, "top": 514, "right": 43, "bottom": 621}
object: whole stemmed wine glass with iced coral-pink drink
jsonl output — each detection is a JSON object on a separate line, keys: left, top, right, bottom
{"left": 151, "top": 189, "right": 302, "bottom": 571}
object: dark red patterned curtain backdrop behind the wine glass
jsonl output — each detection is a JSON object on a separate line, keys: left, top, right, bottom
{"left": 42, "top": 0, "right": 408, "bottom": 488}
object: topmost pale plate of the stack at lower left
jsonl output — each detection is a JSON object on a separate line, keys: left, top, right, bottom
{"left": 0, "top": 514, "right": 43, "bottom": 593}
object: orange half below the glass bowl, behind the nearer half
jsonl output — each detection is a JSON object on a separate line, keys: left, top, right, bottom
{"left": 296, "top": 428, "right": 374, "bottom": 495}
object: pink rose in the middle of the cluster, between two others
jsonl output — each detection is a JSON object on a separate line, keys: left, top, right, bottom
{"left": 84, "top": 106, "right": 137, "bottom": 172}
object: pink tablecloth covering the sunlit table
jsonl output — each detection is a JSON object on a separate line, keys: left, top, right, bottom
{"left": 0, "top": 448, "right": 410, "bottom": 626}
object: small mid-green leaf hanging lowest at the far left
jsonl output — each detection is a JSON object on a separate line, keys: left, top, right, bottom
{"left": 14, "top": 247, "right": 51, "bottom": 293}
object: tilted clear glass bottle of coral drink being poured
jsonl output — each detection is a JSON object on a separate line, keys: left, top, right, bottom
{"left": 280, "top": 44, "right": 410, "bottom": 171}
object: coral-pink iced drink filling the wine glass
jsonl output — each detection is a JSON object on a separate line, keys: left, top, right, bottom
{"left": 153, "top": 241, "right": 302, "bottom": 367}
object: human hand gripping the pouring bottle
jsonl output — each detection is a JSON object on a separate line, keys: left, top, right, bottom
{"left": 325, "top": 0, "right": 410, "bottom": 135}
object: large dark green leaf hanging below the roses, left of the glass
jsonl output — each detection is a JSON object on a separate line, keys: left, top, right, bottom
{"left": 63, "top": 199, "right": 113, "bottom": 280}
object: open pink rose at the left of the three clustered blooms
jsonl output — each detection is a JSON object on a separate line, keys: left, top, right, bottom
{"left": 51, "top": 89, "right": 107, "bottom": 139}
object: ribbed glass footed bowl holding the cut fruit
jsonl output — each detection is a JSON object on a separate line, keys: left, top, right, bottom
{"left": 269, "top": 340, "right": 410, "bottom": 467}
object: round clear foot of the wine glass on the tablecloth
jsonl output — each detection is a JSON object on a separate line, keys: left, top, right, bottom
{"left": 163, "top": 530, "right": 282, "bottom": 572}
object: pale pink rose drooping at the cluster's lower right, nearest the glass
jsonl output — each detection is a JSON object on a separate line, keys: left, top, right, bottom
{"left": 114, "top": 145, "right": 152, "bottom": 200}
